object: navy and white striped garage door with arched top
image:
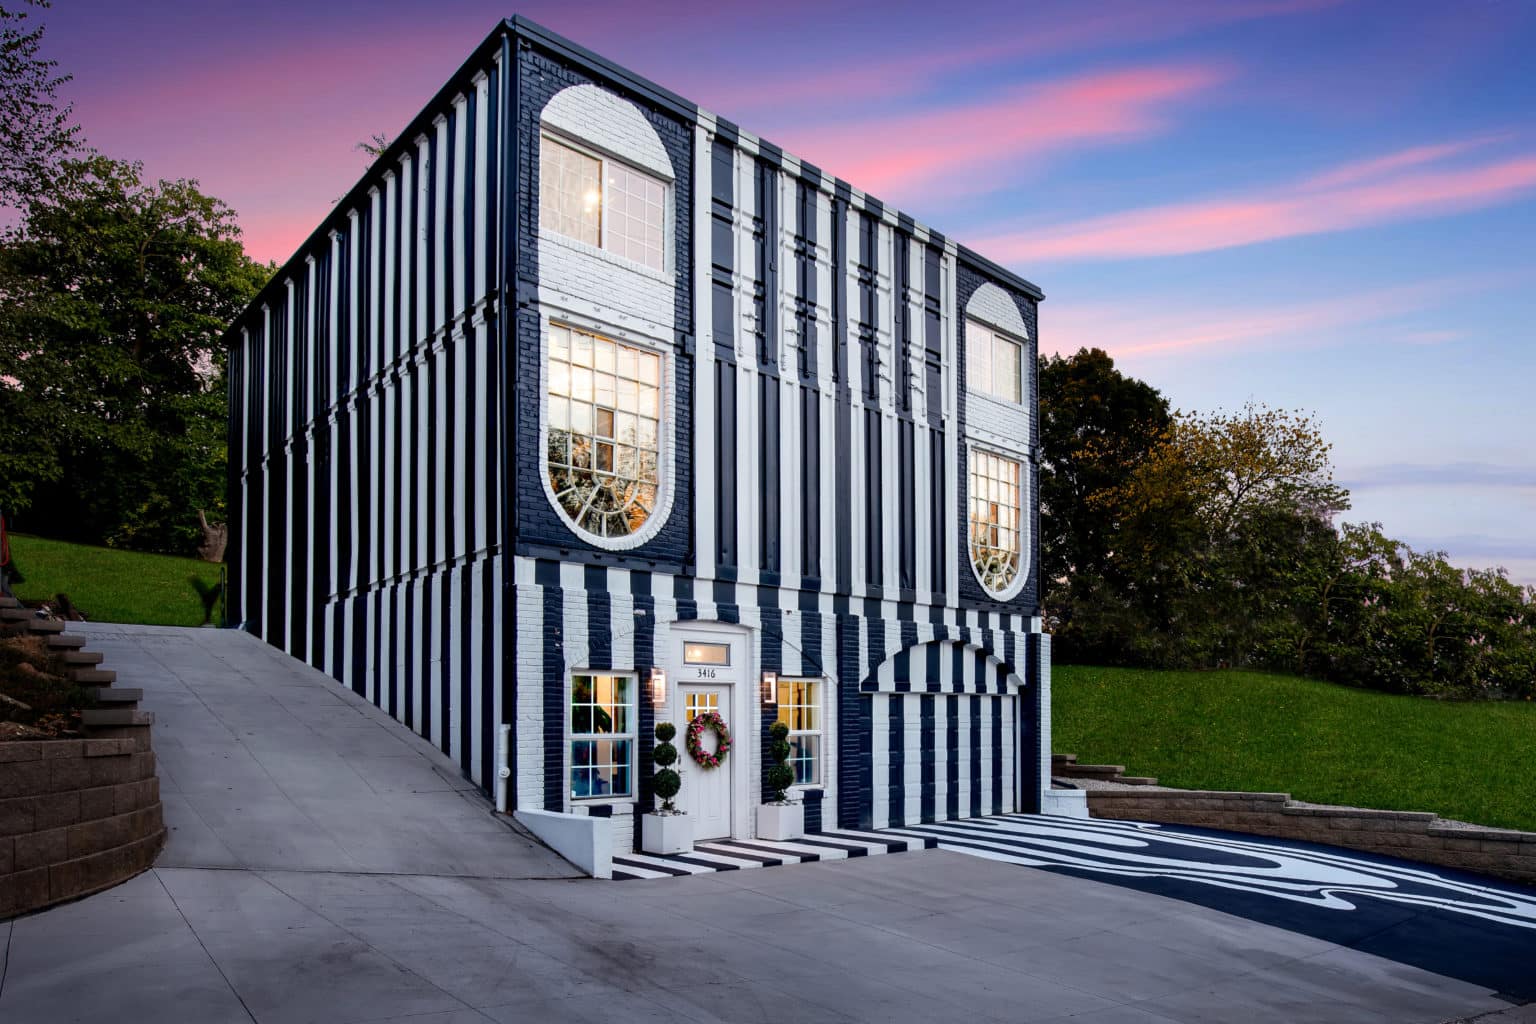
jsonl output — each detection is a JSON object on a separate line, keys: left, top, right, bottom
{"left": 860, "top": 642, "right": 1028, "bottom": 827}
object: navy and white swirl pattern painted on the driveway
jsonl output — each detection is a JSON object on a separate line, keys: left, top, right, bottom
{"left": 892, "top": 815, "right": 1536, "bottom": 1003}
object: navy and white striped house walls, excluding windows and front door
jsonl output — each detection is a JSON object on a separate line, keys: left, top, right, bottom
{"left": 230, "top": 20, "right": 1049, "bottom": 847}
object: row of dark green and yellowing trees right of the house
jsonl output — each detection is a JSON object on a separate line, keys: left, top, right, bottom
{"left": 1040, "top": 348, "right": 1536, "bottom": 697}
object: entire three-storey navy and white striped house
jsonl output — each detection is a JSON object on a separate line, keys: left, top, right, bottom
{"left": 227, "top": 18, "right": 1051, "bottom": 865}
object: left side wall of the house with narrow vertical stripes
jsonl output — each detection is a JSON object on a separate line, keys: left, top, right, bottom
{"left": 230, "top": 42, "right": 505, "bottom": 785}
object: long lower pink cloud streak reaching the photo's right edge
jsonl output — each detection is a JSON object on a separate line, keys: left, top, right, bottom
{"left": 975, "top": 143, "right": 1536, "bottom": 261}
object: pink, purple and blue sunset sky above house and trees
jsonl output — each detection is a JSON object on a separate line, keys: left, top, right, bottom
{"left": 33, "top": 0, "right": 1536, "bottom": 583}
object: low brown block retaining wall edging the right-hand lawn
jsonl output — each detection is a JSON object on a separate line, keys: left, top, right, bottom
{"left": 1087, "top": 788, "right": 1536, "bottom": 884}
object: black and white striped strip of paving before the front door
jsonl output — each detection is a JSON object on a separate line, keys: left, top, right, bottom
{"left": 613, "top": 829, "right": 938, "bottom": 881}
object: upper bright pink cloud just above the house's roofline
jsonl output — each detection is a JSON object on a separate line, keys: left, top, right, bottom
{"left": 783, "top": 66, "right": 1223, "bottom": 195}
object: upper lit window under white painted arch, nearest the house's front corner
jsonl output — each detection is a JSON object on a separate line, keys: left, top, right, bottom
{"left": 539, "top": 135, "right": 667, "bottom": 270}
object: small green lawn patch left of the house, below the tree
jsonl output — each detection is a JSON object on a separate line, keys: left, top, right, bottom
{"left": 11, "top": 534, "right": 220, "bottom": 626}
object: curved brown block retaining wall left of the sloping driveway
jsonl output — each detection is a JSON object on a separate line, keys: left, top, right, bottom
{"left": 0, "top": 725, "right": 166, "bottom": 920}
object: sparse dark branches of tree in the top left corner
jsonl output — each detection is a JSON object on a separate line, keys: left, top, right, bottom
{"left": 0, "top": 0, "right": 80, "bottom": 207}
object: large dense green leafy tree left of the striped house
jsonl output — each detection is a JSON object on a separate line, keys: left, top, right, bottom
{"left": 0, "top": 155, "right": 272, "bottom": 553}
